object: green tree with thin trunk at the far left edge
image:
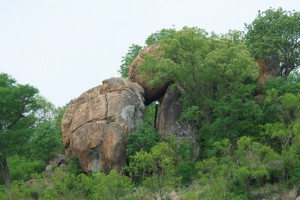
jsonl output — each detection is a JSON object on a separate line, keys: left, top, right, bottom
{"left": 0, "top": 73, "right": 38, "bottom": 199}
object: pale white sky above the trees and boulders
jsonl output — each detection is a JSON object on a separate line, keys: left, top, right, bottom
{"left": 0, "top": 0, "right": 300, "bottom": 106}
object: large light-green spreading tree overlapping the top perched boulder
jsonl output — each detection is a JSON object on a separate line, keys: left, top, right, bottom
{"left": 139, "top": 27, "right": 258, "bottom": 121}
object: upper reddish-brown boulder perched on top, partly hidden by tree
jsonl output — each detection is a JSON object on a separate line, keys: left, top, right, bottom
{"left": 129, "top": 44, "right": 169, "bottom": 105}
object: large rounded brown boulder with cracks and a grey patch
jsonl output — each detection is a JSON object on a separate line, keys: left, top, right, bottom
{"left": 62, "top": 78, "right": 145, "bottom": 172}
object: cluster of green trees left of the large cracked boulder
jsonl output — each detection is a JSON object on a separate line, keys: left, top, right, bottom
{"left": 0, "top": 73, "right": 61, "bottom": 199}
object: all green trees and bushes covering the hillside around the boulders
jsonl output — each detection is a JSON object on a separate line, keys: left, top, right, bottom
{"left": 0, "top": 6, "right": 300, "bottom": 200}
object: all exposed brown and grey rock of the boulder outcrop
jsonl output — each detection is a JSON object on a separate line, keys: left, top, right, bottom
{"left": 62, "top": 45, "right": 278, "bottom": 173}
